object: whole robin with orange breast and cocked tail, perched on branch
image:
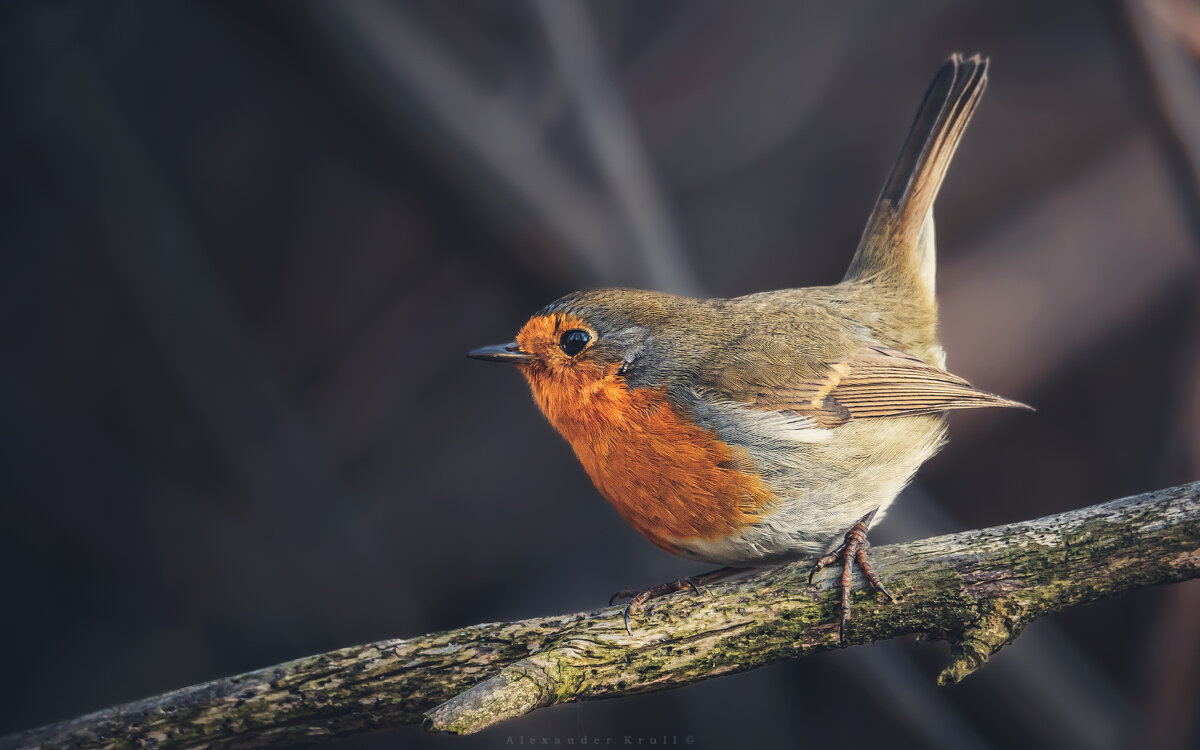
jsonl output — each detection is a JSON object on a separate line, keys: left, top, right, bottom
{"left": 468, "top": 53, "right": 1028, "bottom": 642}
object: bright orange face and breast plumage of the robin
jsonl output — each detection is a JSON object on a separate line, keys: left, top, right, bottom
{"left": 508, "top": 314, "right": 773, "bottom": 553}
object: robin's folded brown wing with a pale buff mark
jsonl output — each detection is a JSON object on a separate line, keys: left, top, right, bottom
{"left": 697, "top": 346, "right": 1028, "bottom": 427}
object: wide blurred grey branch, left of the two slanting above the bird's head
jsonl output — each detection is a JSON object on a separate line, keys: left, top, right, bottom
{"left": 308, "top": 0, "right": 642, "bottom": 284}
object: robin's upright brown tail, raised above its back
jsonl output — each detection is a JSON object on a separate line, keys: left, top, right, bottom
{"left": 846, "top": 53, "right": 988, "bottom": 304}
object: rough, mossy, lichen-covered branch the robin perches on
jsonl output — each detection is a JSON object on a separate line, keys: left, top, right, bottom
{"left": 0, "top": 482, "right": 1200, "bottom": 749}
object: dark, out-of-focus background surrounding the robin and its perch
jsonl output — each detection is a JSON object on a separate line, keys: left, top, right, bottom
{"left": 0, "top": 0, "right": 1200, "bottom": 748}
